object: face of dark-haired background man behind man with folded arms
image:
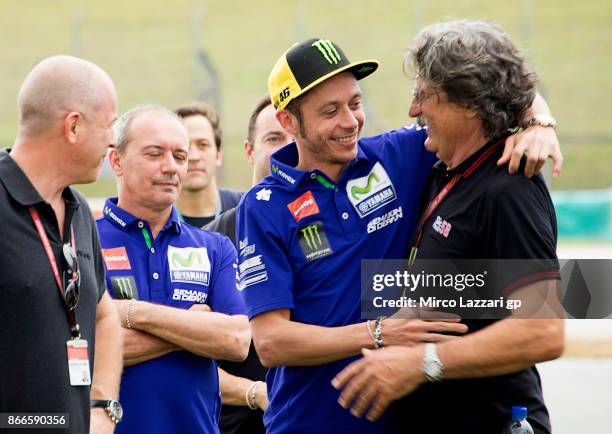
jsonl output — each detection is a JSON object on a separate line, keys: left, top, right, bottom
{"left": 182, "top": 115, "right": 221, "bottom": 192}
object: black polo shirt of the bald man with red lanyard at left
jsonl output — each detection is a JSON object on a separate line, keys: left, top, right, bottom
{"left": 0, "top": 147, "right": 104, "bottom": 434}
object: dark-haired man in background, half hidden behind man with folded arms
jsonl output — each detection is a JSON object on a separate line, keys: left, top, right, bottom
{"left": 175, "top": 103, "right": 242, "bottom": 228}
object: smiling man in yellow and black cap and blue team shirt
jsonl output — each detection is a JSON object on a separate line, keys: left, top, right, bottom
{"left": 238, "top": 39, "right": 556, "bottom": 434}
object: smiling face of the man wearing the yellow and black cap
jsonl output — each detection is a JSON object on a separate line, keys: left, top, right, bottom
{"left": 279, "top": 72, "right": 365, "bottom": 176}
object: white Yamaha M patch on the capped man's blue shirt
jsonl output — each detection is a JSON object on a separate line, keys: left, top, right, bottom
{"left": 346, "top": 161, "right": 397, "bottom": 218}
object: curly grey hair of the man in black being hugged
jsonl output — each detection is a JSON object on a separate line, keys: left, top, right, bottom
{"left": 404, "top": 20, "right": 538, "bottom": 138}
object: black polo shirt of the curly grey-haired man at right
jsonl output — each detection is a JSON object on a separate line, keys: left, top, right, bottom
{"left": 398, "top": 141, "right": 558, "bottom": 434}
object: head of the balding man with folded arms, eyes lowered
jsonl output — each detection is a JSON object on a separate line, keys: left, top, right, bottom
{"left": 110, "top": 111, "right": 188, "bottom": 210}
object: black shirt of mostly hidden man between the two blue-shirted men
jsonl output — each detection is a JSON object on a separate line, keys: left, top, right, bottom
{"left": 202, "top": 207, "right": 268, "bottom": 434}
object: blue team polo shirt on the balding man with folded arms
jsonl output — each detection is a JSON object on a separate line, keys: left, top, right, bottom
{"left": 96, "top": 198, "right": 245, "bottom": 434}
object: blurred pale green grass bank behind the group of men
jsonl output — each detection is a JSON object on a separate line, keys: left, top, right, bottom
{"left": 0, "top": 0, "right": 612, "bottom": 194}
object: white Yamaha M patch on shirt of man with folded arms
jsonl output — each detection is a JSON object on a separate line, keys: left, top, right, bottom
{"left": 168, "top": 246, "right": 210, "bottom": 286}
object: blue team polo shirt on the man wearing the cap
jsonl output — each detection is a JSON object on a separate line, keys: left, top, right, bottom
{"left": 237, "top": 127, "right": 435, "bottom": 434}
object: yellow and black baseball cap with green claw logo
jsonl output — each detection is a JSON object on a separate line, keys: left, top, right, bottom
{"left": 268, "top": 38, "right": 379, "bottom": 110}
